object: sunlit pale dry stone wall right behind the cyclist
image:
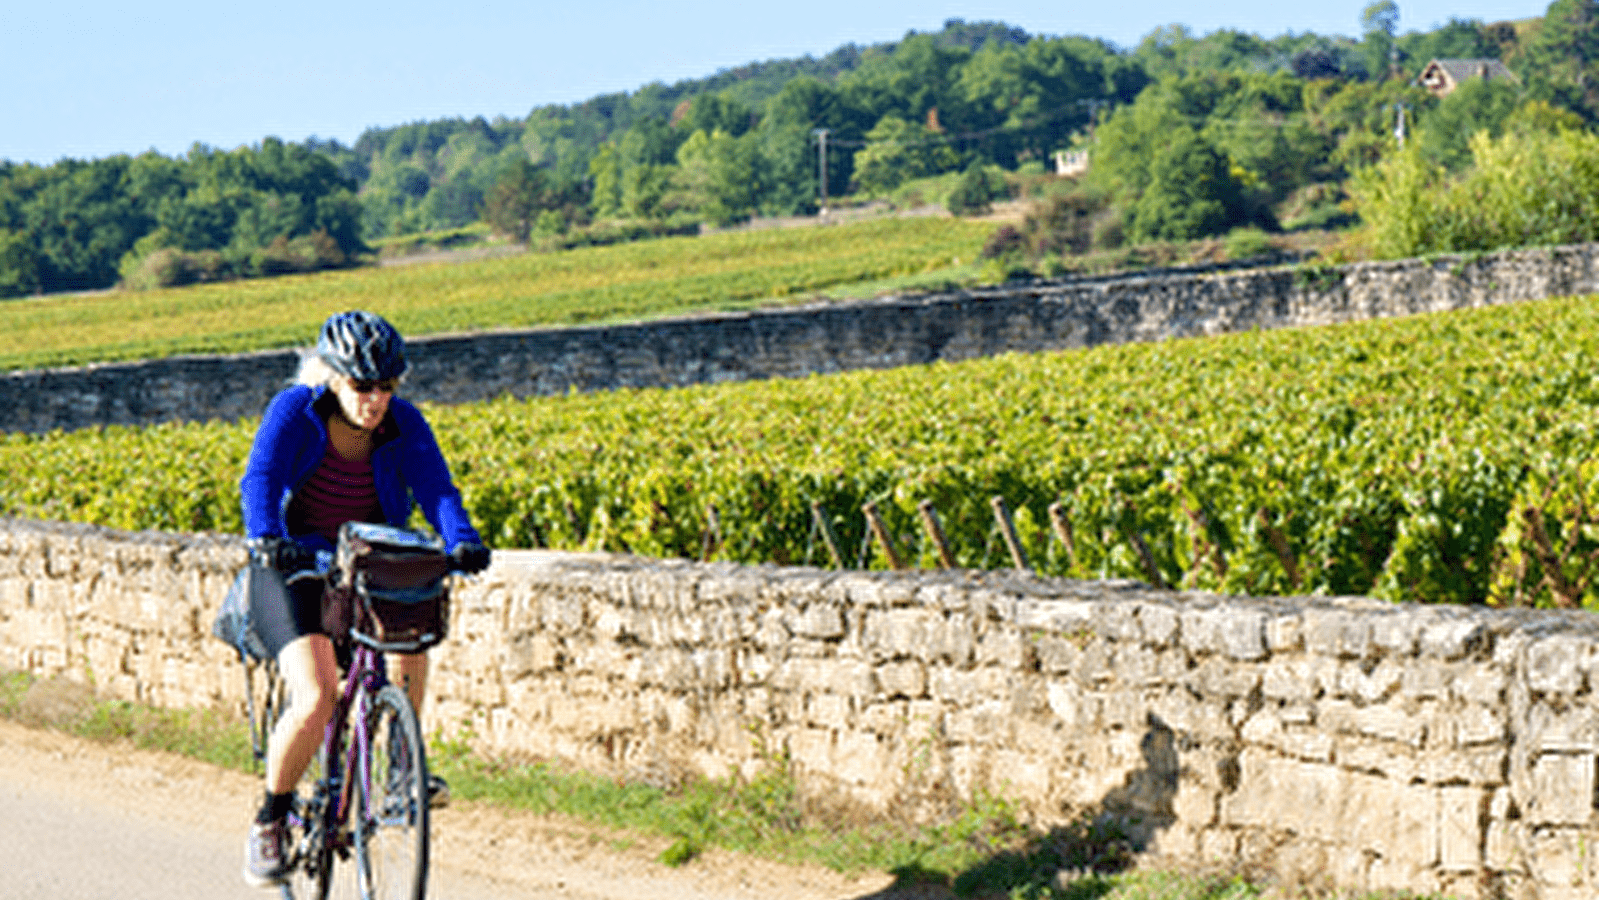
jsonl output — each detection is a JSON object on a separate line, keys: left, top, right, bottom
{"left": 0, "top": 521, "right": 1599, "bottom": 900}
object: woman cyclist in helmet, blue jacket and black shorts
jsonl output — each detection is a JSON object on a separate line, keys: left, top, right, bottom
{"left": 240, "top": 310, "right": 489, "bottom": 887}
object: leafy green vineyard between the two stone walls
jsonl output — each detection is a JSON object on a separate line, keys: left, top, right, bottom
{"left": 9, "top": 297, "right": 1599, "bottom": 606}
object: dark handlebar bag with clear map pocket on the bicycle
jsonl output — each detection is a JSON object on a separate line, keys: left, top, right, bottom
{"left": 323, "top": 521, "right": 449, "bottom": 652}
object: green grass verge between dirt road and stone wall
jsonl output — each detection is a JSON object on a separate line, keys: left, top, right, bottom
{"left": 0, "top": 671, "right": 1458, "bottom": 900}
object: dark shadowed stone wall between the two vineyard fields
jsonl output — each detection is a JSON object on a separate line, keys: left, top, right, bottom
{"left": 9, "top": 245, "right": 1599, "bottom": 432}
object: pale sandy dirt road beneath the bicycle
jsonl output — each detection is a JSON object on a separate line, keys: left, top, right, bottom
{"left": 0, "top": 723, "right": 891, "bottom": 900}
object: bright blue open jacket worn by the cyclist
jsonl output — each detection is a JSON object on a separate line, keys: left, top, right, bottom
{"left": 238, "top": 385, "right": 483, "bottom": 550}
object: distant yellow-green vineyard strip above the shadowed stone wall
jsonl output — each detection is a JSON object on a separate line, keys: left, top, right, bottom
{"left": 0, "top": 217, "right": 991, "bottom": 369}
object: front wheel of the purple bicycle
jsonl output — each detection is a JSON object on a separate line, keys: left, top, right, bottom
{"left": 350, "top": 684, "right": 427, "bottom": 900}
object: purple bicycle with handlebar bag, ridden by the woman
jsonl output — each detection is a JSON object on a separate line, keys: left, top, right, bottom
{"left": 240, "top": 523, "right": 454, "bottom": 900}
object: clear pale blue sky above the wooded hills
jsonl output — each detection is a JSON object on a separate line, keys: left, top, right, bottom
{"left": 0, "top": 0, "right": 1548, "bottom": 163}
